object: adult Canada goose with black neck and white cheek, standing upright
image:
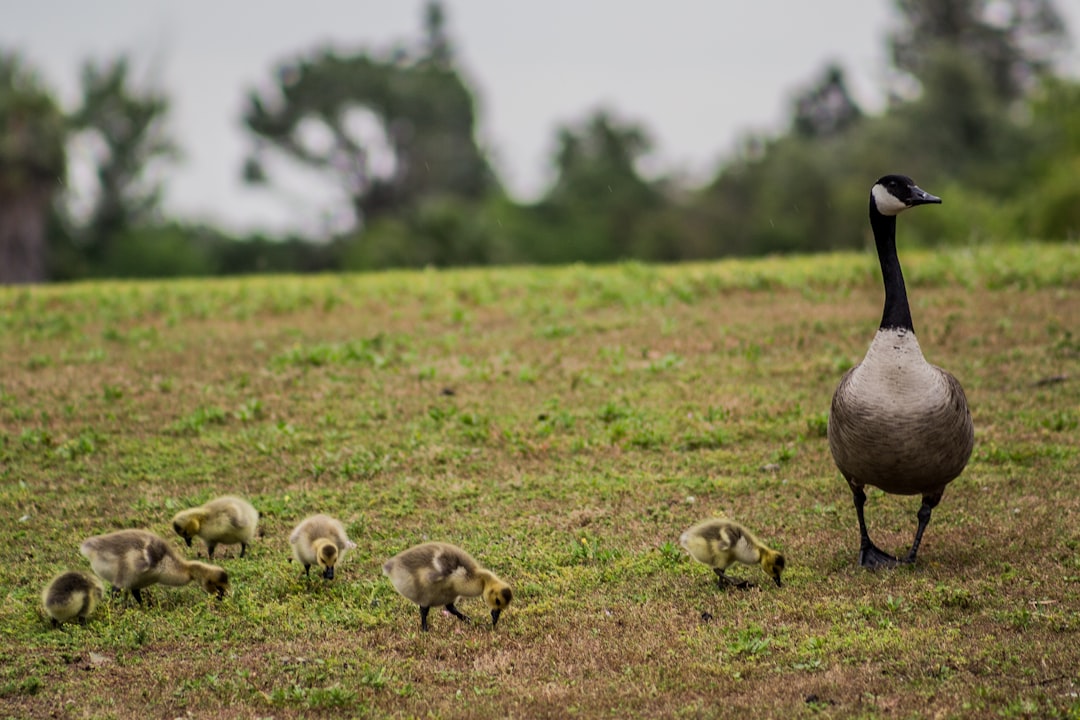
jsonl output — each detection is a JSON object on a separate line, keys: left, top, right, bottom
{"left": 828, "top": 175, "right": 974, "bottom": 568}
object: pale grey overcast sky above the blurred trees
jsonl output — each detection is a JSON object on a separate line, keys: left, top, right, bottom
{"left": 0, "top": 0, "right": 1080, "bottom": 232}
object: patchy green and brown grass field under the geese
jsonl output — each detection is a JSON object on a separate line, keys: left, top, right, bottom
{"left": 0, "top": 245, "right": 1080, "bottom": 718}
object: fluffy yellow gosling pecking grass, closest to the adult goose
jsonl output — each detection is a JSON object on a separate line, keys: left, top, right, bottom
{"left": 678, "top": 517, "right": 784, "bottom": 588}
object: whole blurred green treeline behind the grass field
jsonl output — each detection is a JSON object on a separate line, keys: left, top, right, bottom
{"left": 0, "top": 0, "right": 1080, "bottom": 282}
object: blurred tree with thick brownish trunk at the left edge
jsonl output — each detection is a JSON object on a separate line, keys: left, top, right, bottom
{"left": 0, "top": 53, "right": 66, "bottom": 283}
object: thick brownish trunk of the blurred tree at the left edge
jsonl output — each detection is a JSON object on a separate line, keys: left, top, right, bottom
{"left": 0, "top": 185, "right": 52, "bottom": 285}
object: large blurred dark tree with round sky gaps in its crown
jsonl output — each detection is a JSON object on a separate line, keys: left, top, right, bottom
{"left": 244, "top": 2, "right": 497, "bottom": 229}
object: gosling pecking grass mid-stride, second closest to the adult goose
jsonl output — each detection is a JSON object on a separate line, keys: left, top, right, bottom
{"left": 382, "top": 543, "right": 513, "bottom": 631}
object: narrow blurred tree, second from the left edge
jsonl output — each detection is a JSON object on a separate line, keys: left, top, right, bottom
{"left": 68, "top": 57, "right": 179, "bottom": 263}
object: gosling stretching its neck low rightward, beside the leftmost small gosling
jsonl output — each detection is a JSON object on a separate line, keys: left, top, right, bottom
{"left": 79, "top": 530, "right": 229, "bottom": 604}
